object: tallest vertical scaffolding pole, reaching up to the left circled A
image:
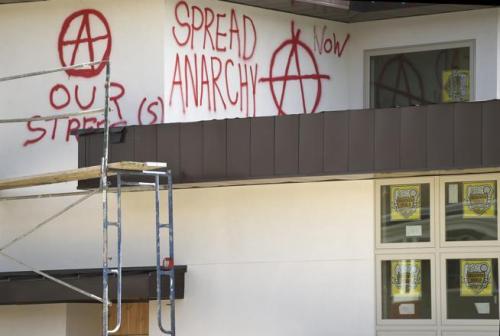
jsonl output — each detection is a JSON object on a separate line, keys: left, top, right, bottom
{"left": 100, "top": 60, "right": 110, "bottom": 336}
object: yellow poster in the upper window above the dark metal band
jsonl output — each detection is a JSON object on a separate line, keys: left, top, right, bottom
{"left": 442, "top": 70, "right": 470, "bottom": 103}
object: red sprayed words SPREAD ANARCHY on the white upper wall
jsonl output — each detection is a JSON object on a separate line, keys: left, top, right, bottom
{"left": 168, "top": 1, "right": 259, "bottom": 116}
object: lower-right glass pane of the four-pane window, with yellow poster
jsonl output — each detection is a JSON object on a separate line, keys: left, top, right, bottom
{"left": 446, "top": 258, "right": 498, "bottom": 319}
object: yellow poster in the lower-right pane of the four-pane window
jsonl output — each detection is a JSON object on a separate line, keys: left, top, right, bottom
{"left": 460, "top": 259, "right": 493, "bottom": 296}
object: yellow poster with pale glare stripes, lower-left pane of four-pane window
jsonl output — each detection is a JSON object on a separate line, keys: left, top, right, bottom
{"left": 391, "top": 260, "right": 422, "bottom": 302}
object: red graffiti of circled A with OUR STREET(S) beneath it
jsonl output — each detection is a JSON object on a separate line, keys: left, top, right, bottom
{"left": 23, "top": 9, "right": 165, "bottom": 146}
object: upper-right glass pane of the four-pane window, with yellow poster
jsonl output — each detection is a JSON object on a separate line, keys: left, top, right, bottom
{"left": 445, "top": 181, "right": 498, "bottom": 241}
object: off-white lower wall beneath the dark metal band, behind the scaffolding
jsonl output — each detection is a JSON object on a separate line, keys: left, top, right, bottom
{"left": 0, "top": 181, "right": 375, "bottom": 336}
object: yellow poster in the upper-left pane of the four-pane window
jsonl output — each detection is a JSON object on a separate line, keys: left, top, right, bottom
{"left": 391, "top": 184, "right": 421, "bottom": 221}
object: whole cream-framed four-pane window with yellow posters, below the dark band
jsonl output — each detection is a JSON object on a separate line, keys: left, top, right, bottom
{"left": 375, "top": 173, "right": 500, "bottom": 336}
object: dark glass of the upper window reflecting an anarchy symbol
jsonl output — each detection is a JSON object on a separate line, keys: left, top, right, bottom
{"left": 370, "top": 47, "right": 471, "bottom": 108}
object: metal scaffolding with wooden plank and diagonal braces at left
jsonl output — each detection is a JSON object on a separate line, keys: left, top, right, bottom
{"left": 0, "top": 60, "right": 175, "bottom": 336}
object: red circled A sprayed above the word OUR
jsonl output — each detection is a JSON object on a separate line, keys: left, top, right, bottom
{"left": 58, "top": 9, "right": 111, "bottom": 78}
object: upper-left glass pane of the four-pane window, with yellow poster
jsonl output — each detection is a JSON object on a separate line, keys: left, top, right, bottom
{"left": 380, "top": 183, "right": 430, "bottom": 243}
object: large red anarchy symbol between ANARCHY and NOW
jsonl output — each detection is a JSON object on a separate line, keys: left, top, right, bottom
{"left": 259, "top": 21, "right": 330, "bottom": 115}
